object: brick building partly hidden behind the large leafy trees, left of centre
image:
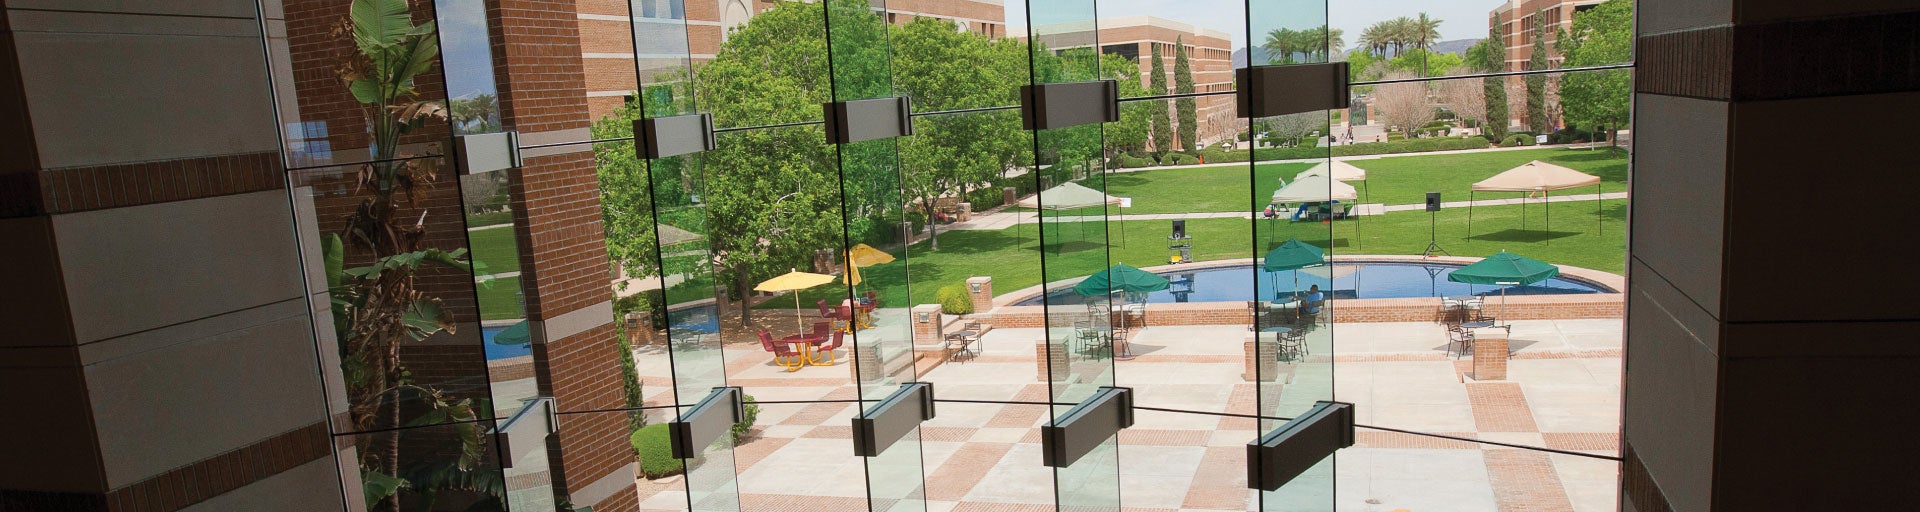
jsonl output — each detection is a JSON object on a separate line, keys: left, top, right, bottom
{"left": 578, "top": 0, "right": 1006, "bottom": 119}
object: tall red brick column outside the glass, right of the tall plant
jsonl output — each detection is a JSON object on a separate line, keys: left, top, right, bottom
{"left": 488, "top": 0, "right": 637, "bottom": 512}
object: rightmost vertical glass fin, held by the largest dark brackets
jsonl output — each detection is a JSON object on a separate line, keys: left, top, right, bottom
{"left": 1244, "top": 0, "right": 1336, "bottom": 510}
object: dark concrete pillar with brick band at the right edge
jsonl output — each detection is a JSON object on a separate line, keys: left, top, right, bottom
{"left": 1620, "top": 0, "right": 1920, "bottom": 512}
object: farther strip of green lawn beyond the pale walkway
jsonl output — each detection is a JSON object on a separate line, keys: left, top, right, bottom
{"left": 1010, "top": 148, "right": 1626, "bottom": 215}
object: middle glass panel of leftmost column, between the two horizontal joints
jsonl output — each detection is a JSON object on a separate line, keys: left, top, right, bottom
{"left": 288, "top": 157, "right": 493, "bottom": 430}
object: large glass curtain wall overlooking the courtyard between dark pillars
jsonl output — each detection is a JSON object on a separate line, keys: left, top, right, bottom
{"left": 263, "top": 0, "right": 1632, "bottom": 510}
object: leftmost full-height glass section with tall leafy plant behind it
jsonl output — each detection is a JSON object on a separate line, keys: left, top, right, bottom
{"left": 259, "top": 0, "right": 518, "bottom": 510}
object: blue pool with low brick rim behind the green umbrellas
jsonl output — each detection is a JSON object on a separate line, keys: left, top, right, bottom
{"left": 1014, "top": 263, "right": 1613, "bottom": 305}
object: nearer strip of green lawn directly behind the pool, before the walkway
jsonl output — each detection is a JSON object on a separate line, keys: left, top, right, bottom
{"left": 762, "top": 199, "right": 1626, "bottom": 309}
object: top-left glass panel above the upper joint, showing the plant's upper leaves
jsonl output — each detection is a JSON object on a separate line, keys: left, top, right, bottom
{"left": 261, "top": 0, "right": 453, "bottom": 169}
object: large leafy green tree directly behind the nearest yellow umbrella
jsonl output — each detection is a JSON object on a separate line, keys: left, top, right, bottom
{"left": 695, "top": 0, "right": 891, "bottom": 324}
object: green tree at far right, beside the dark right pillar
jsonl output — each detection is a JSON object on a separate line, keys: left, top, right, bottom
{"left": 1559, "top": 0, "right": 1634, "bottom": 150}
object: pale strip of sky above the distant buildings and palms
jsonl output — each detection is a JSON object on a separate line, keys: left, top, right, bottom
{"left": 1006, "top": 0, "right": 1503, "bottom": 48}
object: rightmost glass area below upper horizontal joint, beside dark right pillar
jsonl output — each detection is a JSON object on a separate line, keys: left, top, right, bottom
{"left": 1332, "top": 69, "right": 1632, "bottom": 508}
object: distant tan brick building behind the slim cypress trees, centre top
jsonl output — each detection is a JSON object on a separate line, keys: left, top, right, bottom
{"left": 1039, "top": 15, "right": 1244, "bottom": 150}
